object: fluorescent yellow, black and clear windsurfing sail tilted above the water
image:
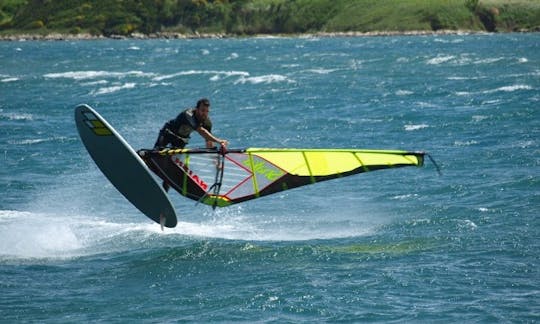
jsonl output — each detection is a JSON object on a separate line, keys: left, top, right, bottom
{"left": 138, "top": 148, "right": 426, "bottom": 207}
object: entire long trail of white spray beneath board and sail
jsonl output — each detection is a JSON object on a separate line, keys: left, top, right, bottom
{"left": 0, "top": 202, "right": 389, "bottom": 261}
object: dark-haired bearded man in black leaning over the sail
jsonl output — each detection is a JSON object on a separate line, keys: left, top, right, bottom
{"left": 154, "top": 98, "right": 229, "bottom": 149}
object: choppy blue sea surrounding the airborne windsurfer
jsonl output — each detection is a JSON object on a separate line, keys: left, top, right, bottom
{"left": 0, "top": 34, "right": 540, "bottom": 323}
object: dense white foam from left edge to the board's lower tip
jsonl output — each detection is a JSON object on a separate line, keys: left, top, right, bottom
{"left": 0, "top": 210, "right": 161, "bottom": 259}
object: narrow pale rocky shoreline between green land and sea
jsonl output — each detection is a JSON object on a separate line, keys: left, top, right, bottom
{"left": 0, "top": 30, "right": 536, "bottom": 41}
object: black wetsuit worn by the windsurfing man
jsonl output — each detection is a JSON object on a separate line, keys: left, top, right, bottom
{"left": 154, "top": 108, "right": 212, "bottom": 149}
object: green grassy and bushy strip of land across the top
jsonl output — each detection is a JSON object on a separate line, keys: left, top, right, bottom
{"left": 0, "top": 0, "right": 540, "bottom": 40}
